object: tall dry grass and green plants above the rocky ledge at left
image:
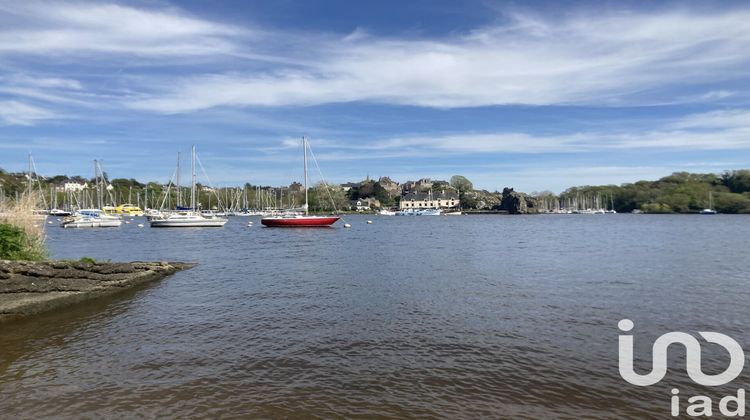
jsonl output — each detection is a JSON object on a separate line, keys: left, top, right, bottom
{"left": 0, "top": 194, "right": 48, "bottom": 261}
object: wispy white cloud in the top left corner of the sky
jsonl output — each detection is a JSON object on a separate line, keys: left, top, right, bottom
{"left": 0, "top": 0, "right": 243, "bottom": 56}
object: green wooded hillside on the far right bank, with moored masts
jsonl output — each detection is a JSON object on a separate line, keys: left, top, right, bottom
{"left": 536, "top": 169, "right": 750, "bottom": 213}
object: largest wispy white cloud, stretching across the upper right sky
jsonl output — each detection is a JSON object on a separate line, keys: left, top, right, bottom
{"left": 130, "top": 10, "right": 750, "bottom": 113}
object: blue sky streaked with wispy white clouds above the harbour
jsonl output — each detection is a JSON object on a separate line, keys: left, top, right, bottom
{"left": 0, "top": 0, "right": 750, "bottom": 192}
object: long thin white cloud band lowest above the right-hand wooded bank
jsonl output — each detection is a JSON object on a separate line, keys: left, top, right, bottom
{"left": 300, "top": 109, "right": 750, "bottom": 161}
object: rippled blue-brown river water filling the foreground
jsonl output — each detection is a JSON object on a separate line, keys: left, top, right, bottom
{"left": 0, "top": 215, "right": 750, "bottom": 418}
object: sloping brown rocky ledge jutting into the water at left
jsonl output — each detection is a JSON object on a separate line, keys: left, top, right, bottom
{"left": 0, "top": 260, "right": 195, "bottom": 322}
